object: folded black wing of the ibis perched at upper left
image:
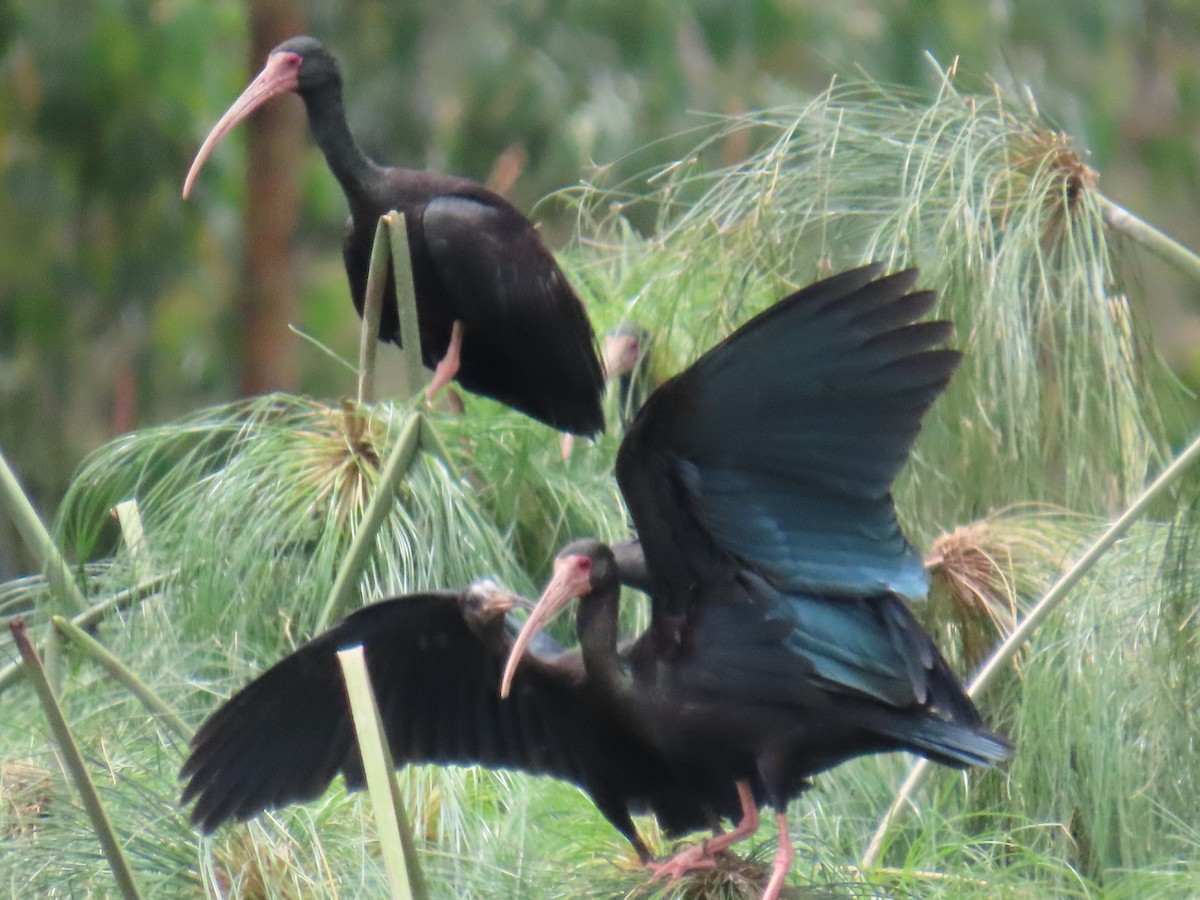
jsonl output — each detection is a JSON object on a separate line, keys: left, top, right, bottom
{"left": 422, "top": 194, "right": 604, "bottom": 434}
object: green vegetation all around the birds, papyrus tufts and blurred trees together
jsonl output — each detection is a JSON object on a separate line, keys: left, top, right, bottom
{"left": 0, "top": 0, "right": 1200, "bottom": 898}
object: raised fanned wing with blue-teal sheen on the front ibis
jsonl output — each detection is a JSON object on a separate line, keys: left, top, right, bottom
{"left": 617, "top": 265, "right": 959, "bottom": 616}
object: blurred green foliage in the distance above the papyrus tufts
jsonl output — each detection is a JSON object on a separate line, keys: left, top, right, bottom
{"left": 0, "top": 0, "right": 1200, "bottom": 577}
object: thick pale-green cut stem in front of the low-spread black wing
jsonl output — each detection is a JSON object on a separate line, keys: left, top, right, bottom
{"left": 337, "top": 644, "right": 428, "bottom": 900}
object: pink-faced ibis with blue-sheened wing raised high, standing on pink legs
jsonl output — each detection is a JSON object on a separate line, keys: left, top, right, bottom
{"left": 502, "top": 266, "right": 1012, "bottom": 899}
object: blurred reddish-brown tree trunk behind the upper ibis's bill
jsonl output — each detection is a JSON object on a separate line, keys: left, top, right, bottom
{"left": 240, "top": 0, "right": 305, "bottom": 396}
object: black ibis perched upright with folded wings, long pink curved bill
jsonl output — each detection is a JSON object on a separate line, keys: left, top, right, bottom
{"left": 184, "top": 37, "right": 604, "bottom": 434}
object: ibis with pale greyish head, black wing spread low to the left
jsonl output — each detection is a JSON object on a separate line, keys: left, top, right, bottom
{"left": 181, "top": 580, "right": 739, "bottom": 863}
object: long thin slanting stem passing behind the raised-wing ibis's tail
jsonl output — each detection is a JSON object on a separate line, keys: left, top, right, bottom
{"left": 860, "top": 437, "right": 1200, "bottom": 869}
